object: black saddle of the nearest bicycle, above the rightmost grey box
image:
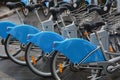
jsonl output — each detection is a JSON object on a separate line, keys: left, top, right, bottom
{"left": 82, "top": 22, "right": 105, "bottom": 32}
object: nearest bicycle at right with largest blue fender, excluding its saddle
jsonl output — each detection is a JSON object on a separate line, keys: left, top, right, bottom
{"left": 51, "top": 29, "right": 120, "bottom": 80}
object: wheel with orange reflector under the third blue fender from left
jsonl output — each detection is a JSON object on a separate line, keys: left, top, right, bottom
{"left": 25, "top": 43, "right": 52, "bottom": 77}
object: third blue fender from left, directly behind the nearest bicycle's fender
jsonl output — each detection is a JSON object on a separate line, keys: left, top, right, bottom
{"left": 28, "top": 31, "right": 64, "bottom": 54}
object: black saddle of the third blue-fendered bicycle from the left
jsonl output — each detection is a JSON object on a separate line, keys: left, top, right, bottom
{"left": 50, "top": 7, "right": 67, "bottom": 20}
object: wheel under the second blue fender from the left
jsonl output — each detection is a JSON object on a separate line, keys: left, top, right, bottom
{"left": 5, "top": 34, "right": 26, "bottom": 65}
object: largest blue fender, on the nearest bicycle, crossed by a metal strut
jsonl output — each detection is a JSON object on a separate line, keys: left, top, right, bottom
{"left": 54, "top": 38, "right": 105, "bottom": 63}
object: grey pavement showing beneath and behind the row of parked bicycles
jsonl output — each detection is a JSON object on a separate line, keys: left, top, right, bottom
{"left": 0, "top": 6, "right": 120, "bottom": 80}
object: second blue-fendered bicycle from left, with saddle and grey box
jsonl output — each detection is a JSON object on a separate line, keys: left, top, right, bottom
{"left": 5, "top": 1, "right": 72, "bottom": 65}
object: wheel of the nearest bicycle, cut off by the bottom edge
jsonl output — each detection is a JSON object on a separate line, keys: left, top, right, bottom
{"left": 51, "top": 51, "right": 88, "bottom": 80}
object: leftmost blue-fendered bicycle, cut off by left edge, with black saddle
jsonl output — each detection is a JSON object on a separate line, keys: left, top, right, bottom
{"left": 0, "top": 2, "right": 26, "bottom": 58}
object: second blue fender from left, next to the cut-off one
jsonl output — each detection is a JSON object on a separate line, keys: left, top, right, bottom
{"left": 7, "top": 24, "right": 40, "bottom": 44}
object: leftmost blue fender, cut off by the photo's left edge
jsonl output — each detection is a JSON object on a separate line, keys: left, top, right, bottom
{"left": 0, "top": 21, "right": 16, "bottom": 39}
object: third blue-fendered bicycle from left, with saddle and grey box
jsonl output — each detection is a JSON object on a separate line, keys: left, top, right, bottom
{"left": 25, "top": 0, "right": 112, "bottom": 77}
